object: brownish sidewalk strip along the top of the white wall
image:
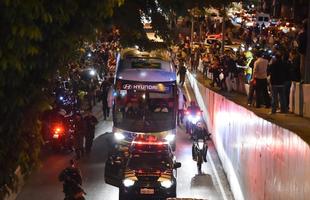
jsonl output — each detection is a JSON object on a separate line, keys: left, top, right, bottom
{"left": 196, "top": 72, "right": 310, "bottom": 144}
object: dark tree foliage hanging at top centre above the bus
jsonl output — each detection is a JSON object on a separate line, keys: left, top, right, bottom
{"left": 111, "top": 0, "right": 233, "bottom": 48}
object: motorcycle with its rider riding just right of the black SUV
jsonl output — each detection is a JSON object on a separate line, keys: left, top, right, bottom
{"left": 192, "top": 122, "right": 211, "bottom": 173}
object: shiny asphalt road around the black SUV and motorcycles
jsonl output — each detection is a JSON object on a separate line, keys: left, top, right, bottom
{"left": 17, "top": 81, "right": 233, "bottom": 200}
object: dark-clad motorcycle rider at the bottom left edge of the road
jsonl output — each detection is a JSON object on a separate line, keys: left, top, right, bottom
{"left": 58, "top": 160, "right": 86, "bottom": 200}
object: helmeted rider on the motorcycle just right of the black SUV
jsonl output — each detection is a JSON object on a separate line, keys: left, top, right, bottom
{"left": 192, "top": 122, "right": 211, "bottom": 162}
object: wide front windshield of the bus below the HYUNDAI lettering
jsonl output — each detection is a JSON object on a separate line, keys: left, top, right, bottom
{"left": 113, "top": 81, "right": 176, "bottom": 132}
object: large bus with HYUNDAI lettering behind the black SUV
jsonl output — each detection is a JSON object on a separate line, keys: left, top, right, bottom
{"left": 113, "top": 49, "right": 178, "bottom": 149}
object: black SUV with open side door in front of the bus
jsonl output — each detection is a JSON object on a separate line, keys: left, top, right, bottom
{"left": 105, "top": 145, "right": 181, "bottom": 200}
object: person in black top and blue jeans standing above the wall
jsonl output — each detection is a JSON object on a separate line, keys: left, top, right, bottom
{"left": 268, "top": 53, "right": 288, "bottom": 114}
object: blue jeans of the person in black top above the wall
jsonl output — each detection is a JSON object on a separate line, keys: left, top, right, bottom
{"left": 271, "top": 85, "right": 287, "bottom": 113}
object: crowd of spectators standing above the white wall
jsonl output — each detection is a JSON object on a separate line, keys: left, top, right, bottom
{"left": 174, "top": 16, "right": 307, "bottom": 114}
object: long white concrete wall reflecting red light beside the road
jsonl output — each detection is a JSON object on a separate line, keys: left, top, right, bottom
{"left": 188, "top": 74, "right": 310, "bottom": 200}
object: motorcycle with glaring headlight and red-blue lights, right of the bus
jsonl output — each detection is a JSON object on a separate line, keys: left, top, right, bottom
{"left": 185, "top": 101, "right": 202, "bottom": 137}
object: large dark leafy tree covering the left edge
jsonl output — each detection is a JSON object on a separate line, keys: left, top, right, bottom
{"left": 0, "top": 0, "right": 123, "bottom": 199}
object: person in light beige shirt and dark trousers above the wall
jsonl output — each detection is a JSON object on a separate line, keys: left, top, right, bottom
{"left": 253, "top": 52, "right": 270, "bottom": 108}
